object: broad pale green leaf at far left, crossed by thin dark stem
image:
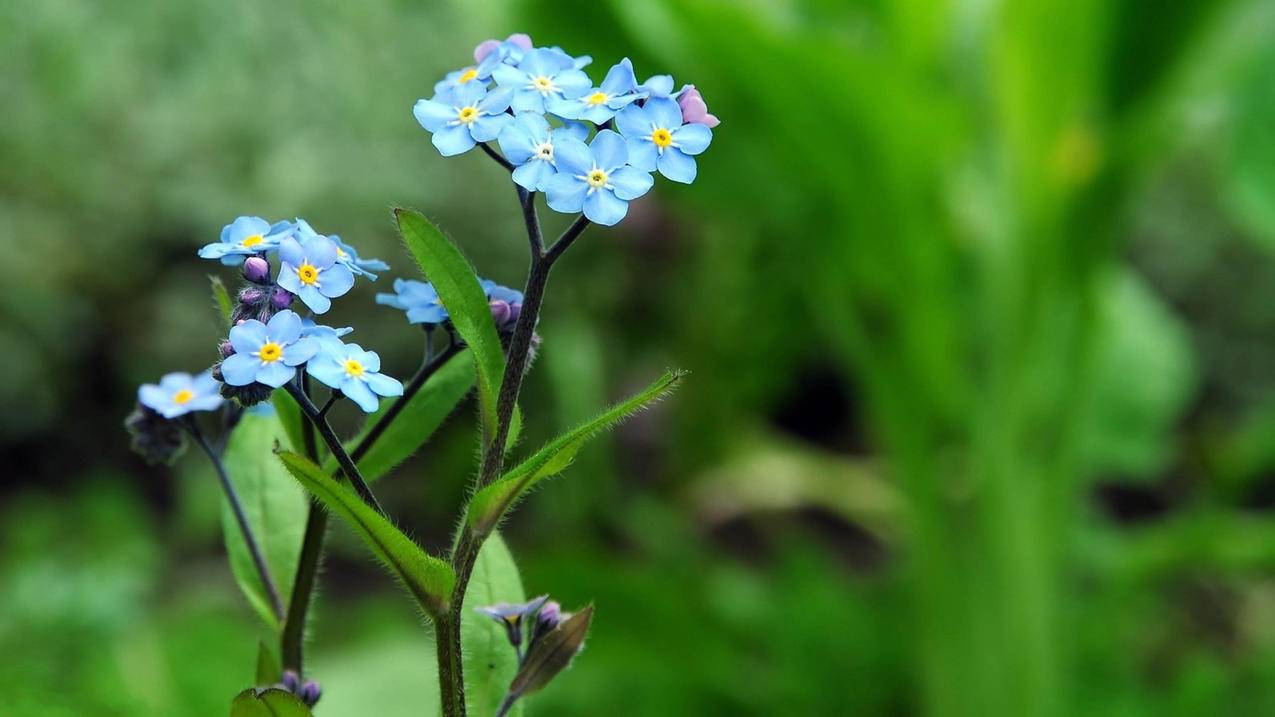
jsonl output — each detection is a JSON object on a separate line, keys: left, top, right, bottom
{"left": 222, "top": 408, "right": 309, "bottom": 629}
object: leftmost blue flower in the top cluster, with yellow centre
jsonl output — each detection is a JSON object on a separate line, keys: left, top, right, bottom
{"left": 412, "top": 82, "right": 514, "bottom": 157}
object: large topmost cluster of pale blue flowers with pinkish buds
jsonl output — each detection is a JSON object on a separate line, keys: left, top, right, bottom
{"left": 413, "top": 34, "right": 719, "bottom": 226}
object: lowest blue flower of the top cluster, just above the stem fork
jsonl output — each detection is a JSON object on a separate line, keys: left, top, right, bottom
{"left": 544, "top": 129, "right": 654, "bottom": 226}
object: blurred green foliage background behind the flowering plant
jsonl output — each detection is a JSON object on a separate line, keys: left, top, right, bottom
{"left": 0, "top": 0, "right": 1275, "bottom": 717}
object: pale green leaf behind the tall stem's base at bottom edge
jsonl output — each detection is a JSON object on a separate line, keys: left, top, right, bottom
{"left": 460, "top": 533, "right": 525, "bottom": 714}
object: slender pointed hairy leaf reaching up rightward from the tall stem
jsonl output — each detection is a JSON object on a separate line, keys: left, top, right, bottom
{"left": 467, "top": 370, "right": 686, "bottom": 536}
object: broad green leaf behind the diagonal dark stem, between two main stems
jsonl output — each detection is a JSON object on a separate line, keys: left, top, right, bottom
{"left": 321, "top": 352, "right": 474, "bottom": 482}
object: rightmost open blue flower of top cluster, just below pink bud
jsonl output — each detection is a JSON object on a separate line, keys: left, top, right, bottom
{"left": 616, "top": 97, "right": 713, "bottom": 184}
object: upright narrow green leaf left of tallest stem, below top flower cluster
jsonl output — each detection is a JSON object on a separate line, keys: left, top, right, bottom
{"left": 394, "top": 209, "right": 505, "bottom": 436}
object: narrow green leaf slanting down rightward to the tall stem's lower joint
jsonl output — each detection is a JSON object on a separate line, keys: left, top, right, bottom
{"left": 279, "top": 450, "right": 456, "bottom": 616}
